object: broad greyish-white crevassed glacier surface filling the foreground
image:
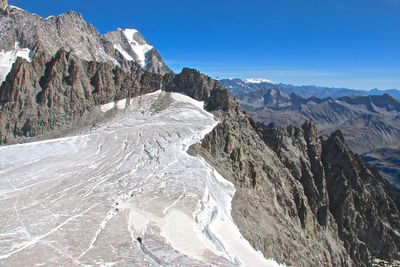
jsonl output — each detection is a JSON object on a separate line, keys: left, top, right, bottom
{"left": 0, "top": 91, "right": 279, "bottom": 266}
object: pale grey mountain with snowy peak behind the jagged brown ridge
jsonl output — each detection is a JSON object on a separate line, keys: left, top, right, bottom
{"left": 0, "top": 5, "right": 170, "bottom": 74}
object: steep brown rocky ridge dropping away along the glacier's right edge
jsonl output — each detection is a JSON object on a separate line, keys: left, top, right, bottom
{"left": 166, "top": 70, "right": 400, "bottom": 266}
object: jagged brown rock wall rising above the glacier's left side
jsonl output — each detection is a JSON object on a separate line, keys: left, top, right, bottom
{"left": 0, "top": 49, "right": 162, "bottom": 143}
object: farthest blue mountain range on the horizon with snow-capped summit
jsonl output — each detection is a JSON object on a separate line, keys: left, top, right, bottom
{"left": 220, "top": 78, "right": 400, "bottom": 99}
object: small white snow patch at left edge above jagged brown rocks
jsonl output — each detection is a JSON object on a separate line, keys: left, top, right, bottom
{"left": 0, "top": 42, "right": 32, "bottom": 84}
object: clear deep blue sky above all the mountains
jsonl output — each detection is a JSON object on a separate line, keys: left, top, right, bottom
{"left": 9, "top": 0, "right": 400, "bottom": 89}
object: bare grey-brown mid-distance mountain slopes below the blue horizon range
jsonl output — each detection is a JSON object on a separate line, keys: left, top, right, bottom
{"left": 223, "top": 84, "right": 400, "bottom": 153}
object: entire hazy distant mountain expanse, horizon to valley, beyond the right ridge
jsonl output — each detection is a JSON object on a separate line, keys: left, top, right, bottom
{"left": 220, "top": 79, "right": 400, "bottom": 193}
